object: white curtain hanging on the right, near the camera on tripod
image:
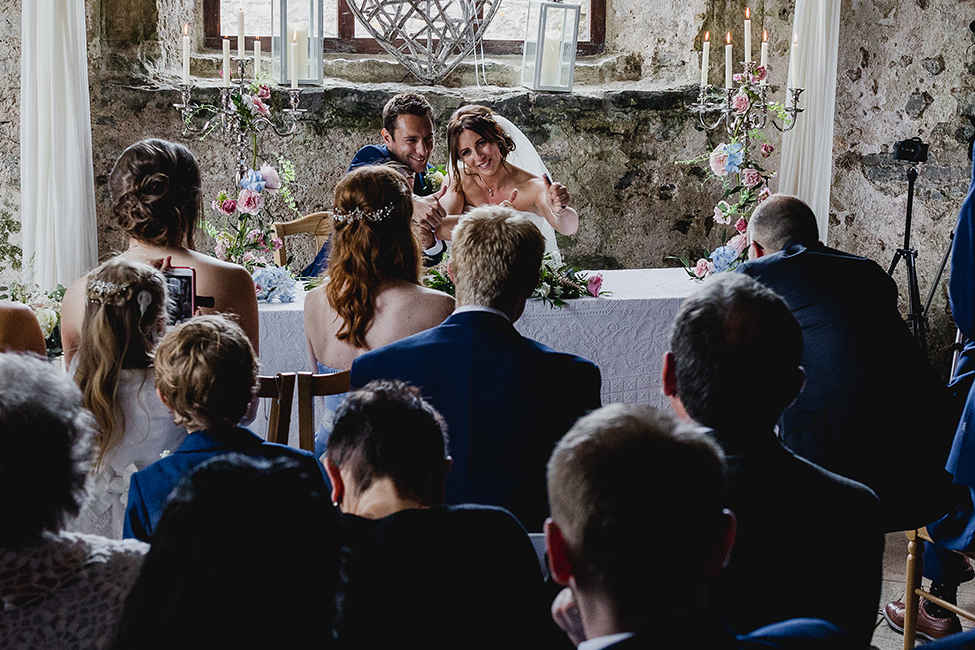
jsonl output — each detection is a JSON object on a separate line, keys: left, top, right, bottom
{"left": 779, "top": 0, "right": 840, "bottom": 242}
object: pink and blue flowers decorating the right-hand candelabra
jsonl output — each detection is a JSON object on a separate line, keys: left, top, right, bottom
{"left": 671, "top": 63, "right": 790, "bottom": 280}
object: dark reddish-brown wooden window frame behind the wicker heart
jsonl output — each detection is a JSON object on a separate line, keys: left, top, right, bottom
{"left": 203, "top": 0, "right": 606, "bottom": 56}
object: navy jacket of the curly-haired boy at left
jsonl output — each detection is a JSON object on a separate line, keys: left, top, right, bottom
{"left": 122, "top": 427, "right": 325, "bottom": 542}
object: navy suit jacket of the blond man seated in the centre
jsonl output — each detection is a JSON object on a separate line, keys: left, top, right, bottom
{"left": 352, "top": 311, "right": 600, "bottom": 532}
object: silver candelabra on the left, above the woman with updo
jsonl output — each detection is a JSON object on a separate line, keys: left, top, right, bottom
{"left": 173, "top": 57, "right": 307, "bottom": 183}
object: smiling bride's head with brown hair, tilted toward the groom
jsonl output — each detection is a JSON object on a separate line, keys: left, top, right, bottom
{"left": 447, "top": 104, "right": 515, "bottom": 188}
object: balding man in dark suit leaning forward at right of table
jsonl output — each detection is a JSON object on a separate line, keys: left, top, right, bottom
{"left": 738, "top": 194, "right": 954, "bottom": 531}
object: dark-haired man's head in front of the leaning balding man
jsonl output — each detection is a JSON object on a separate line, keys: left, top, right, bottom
{"left": 663, "top": 273, "right": 804, "bottom": 433}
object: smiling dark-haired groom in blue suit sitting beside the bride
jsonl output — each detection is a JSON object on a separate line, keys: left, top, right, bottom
{"left": 302, "top": 93, "right": 447, "bottom": 277}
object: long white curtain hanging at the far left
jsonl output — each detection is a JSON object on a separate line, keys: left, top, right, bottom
{"left": 20, "top": 0, "right": 98, "bottom": 289}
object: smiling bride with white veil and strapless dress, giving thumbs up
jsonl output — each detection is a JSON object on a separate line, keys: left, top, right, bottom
{"left": 437, "top": 105, "right": 579, "bottom": 264}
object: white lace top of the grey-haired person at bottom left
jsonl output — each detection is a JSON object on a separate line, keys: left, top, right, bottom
{"left": 0, "top": 532, "right": 149, "bottom": 650}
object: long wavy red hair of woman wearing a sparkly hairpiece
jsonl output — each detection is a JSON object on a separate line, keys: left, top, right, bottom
{"left": 325, "top": 166, "right": 420, "bottom": 348}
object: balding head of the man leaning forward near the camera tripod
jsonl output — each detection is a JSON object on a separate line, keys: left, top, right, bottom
{"left": 748, "top": 194, "right": 819, "bottom": 260}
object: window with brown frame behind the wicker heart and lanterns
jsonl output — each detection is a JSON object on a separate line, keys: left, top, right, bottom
{"left": 203, "top": 0, "right": 606, "bottom": 55}
